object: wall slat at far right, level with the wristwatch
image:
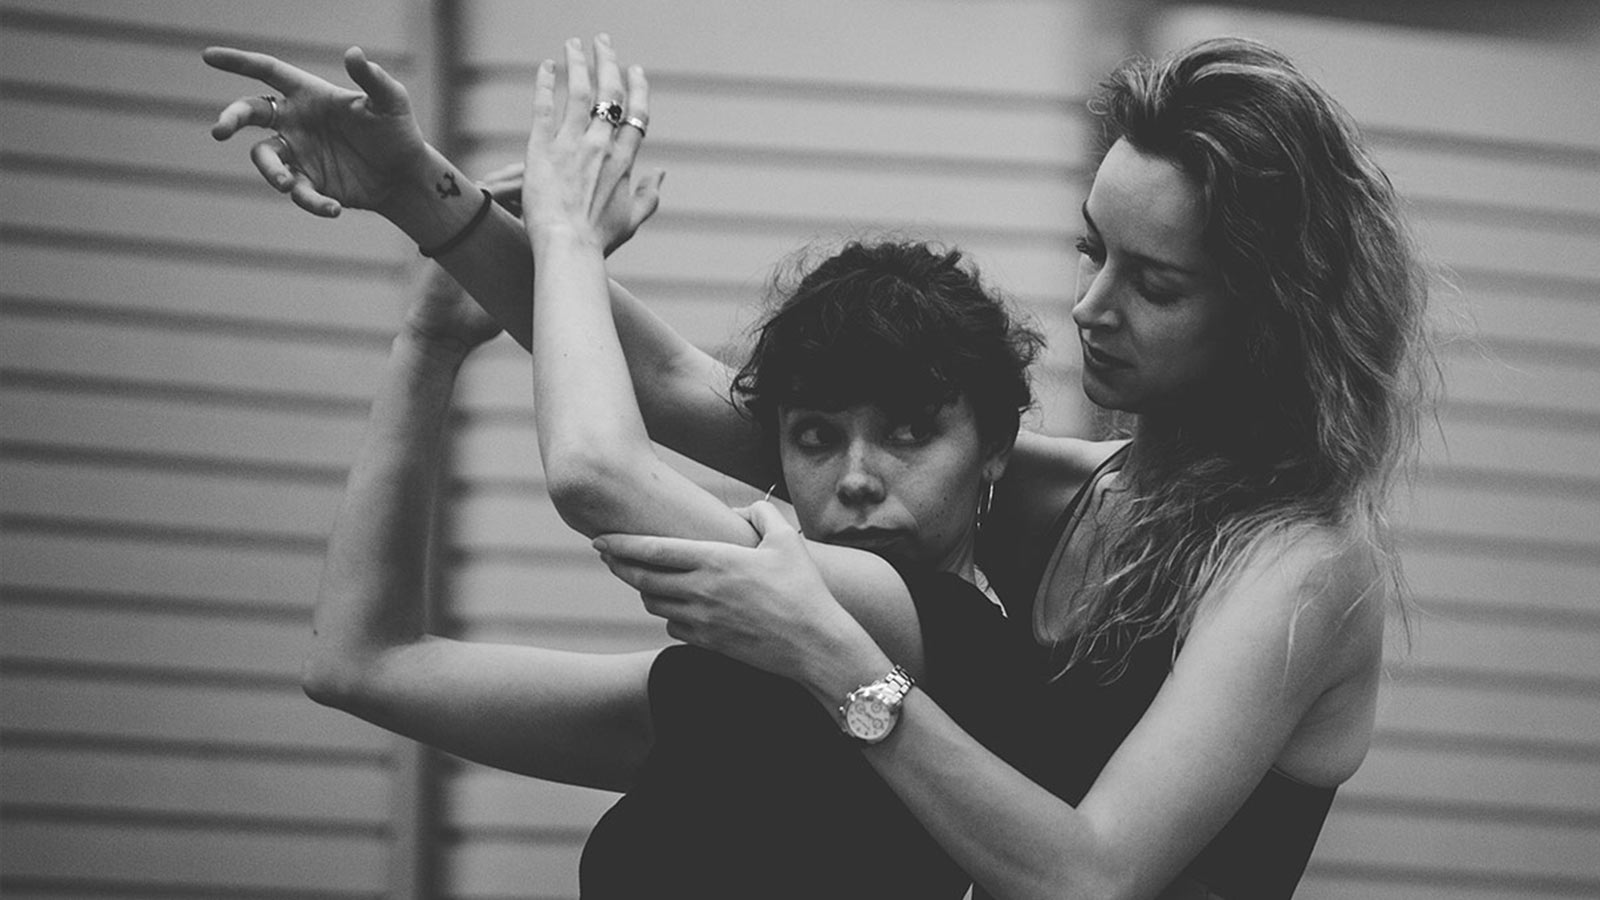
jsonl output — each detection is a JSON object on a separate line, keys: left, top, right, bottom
{"left": 1378, "top": 676, "right": 1600, "bottom": 746}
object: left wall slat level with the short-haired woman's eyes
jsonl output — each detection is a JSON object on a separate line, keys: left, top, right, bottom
{"left": 0, "top": 388, "right": 363, "bottom": 471}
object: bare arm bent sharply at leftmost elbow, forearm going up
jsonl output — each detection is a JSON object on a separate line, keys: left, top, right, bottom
{"left": 302, "top": 267, "right": 653, "bottom": 790}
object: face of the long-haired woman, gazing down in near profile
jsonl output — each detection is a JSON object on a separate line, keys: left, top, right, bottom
{"left": 1072, "top": 141, "right": 1237, "bottom": 413}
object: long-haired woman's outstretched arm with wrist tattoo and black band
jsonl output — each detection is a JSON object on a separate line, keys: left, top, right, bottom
{"left": 203, "top": 46, "right": 774, "bottom": 487}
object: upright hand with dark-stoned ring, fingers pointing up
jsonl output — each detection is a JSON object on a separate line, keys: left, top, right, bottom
{"left": 522, "top": 35, "right": 664, "bottom": 253}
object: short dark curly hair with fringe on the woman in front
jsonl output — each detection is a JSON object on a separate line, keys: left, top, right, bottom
{"left": 731, "top": 240, "right": 1043, "bottom": 453}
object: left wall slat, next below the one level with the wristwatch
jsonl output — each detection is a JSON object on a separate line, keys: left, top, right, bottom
{"left": 0, "top": 746, "right": 389, "bottom": 826}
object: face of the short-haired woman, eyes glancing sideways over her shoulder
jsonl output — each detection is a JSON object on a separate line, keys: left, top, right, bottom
{"left": 778, "top": 397, "right": 1003, "bottom": 572}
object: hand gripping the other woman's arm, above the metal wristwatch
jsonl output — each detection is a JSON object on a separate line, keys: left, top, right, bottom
{"left": 594, "top": 501, "right": 861, "bottom": 681}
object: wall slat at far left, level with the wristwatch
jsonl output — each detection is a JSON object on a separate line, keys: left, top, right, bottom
{"left": 0, "top": 671, "right": 392, "bottom": 754}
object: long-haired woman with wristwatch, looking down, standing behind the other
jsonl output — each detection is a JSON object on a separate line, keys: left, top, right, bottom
{"left": 206, "top": 29, "right": 1426, "bottom": 897}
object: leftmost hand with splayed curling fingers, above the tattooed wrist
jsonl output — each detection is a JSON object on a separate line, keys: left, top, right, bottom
{"left": 202, "top": 46, "right": 432, "bottom": 218}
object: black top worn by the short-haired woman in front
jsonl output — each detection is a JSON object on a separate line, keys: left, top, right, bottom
{"left": 579, "top": 570, "right": 1042, "bottom": 900}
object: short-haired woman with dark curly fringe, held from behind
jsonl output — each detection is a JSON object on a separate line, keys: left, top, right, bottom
{"left": 296, "top": 38, "right": 1040, "bottom": 900}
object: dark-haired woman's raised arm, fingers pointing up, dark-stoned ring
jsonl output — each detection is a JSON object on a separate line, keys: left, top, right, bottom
{"left": 523, "top": 35, "right": 922, "bottom": 666}
